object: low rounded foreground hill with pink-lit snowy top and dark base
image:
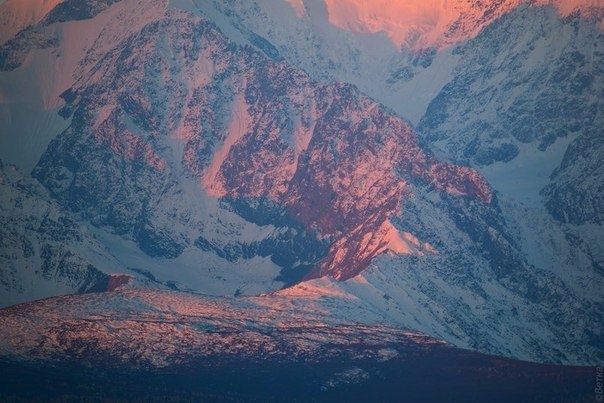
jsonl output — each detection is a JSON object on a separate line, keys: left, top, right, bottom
{"left": 0, "top": 289, "right": 594, "bottom": 402}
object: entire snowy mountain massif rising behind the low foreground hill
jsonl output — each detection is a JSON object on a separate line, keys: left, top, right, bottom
{"left": 0, "top": 0, "right": 604, "bottom": 378}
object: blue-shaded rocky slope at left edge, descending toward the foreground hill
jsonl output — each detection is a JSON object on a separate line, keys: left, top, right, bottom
{"left": 0, "top": 162, "right": 126, "bottom": 305}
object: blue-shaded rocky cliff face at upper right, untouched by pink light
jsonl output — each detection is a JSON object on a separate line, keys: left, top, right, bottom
{"left": 419, "top": 7, "right": 604, "bottom": 229}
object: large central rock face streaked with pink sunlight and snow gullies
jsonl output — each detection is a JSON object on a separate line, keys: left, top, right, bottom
{"left": 29, "top": 7, "right": 491, "bottom": 280}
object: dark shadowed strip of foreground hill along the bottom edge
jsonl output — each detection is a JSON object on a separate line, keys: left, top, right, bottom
{"left": 0, "top": 345, "right": 596, "bottom": 402}
